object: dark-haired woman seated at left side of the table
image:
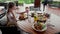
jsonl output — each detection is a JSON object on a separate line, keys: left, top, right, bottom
{"left": 7, "top": 2, "right": 17, "bottom": 26}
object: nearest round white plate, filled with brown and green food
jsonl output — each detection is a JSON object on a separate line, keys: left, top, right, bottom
{"left": 32, "top": 23, "right": 47, "bottom": 32}
